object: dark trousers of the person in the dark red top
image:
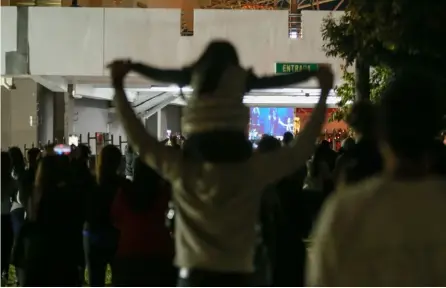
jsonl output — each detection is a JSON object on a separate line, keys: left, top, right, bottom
{"left": 113, "top": 257, "right": 177, "bottom": 287}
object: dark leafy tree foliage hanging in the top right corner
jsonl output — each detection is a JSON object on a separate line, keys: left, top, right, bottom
{"left": 322, "top": 0, "right": 446, "bottom": 120}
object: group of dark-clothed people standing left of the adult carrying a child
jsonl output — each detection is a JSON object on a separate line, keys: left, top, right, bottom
{"left": 1, "top": 145, "right": 176, "bottom": 287}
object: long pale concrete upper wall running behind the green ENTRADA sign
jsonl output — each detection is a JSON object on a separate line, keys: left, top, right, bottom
{"left": 1, "top": 7, "right": 343, "bottom": 86}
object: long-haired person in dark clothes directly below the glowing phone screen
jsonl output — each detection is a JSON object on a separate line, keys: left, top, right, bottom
{"left": 23, "top": 155, "right": 82, "bottom": 287}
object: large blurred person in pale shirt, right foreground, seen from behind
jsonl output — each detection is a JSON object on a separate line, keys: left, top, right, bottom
{"left": 307, "top": 68, "right": 446, "bottom": 287}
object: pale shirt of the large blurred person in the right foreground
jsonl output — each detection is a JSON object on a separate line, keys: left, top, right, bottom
{"left": 307, "top": 177, "right": 446, "bottom": 287}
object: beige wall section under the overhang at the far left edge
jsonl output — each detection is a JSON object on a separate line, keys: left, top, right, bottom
{"left": 0, "top": 79, "right": 39, "bottom": 149}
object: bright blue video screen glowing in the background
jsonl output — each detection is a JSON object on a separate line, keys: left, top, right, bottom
{"left": 249, "top": 107, "right": 294, "bottom": 140}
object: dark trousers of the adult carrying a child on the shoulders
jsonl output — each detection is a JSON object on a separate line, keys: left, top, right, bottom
{"left": 177, "top": 269, "right": 253, "bottom": 287}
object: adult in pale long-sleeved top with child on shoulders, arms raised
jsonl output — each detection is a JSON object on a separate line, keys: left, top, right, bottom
{"left": 106, "top": 41, "right": 333, "bottom": 286}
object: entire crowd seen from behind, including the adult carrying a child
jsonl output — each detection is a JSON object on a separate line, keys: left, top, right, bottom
{"left": 1, "top": 43, "right": 446, "bottom": 287}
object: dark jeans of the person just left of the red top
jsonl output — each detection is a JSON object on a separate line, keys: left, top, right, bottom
{"left": 84, "top": 236, "right": 115, "bottom": 287}
